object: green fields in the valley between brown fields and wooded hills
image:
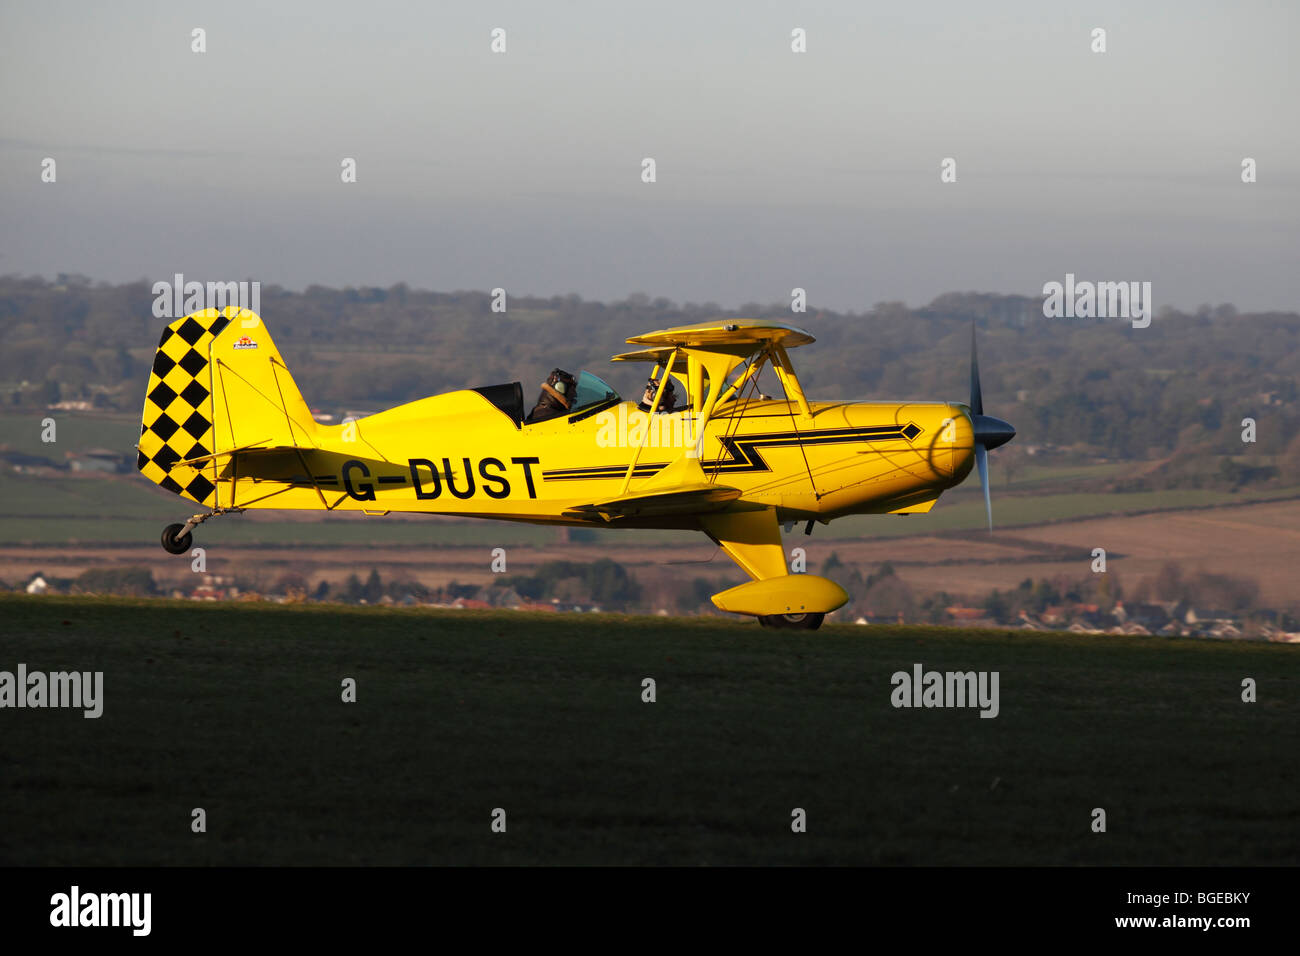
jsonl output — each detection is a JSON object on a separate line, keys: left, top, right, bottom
{"left": 0, "top": 412, "right": 1300, "bottom": 546}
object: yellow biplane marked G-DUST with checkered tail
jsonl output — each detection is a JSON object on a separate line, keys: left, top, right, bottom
{"left": 137, "top": 306, "right": 1015, "bottom": 628}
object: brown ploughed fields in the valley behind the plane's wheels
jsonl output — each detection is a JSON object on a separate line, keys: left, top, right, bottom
{"left": 0, "top": 501, "right": 1300, "bottom": 613}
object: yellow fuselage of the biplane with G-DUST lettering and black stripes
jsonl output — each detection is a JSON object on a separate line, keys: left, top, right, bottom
{"left": 236, "top": 390, "right": 974, "bottom": 528}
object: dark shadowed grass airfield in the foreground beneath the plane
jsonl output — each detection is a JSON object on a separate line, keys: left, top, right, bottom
{"left": 0, "top": 596, "right": 1300, "bottom": 865}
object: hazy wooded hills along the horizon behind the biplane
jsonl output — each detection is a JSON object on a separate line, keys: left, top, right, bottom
{"left": 0, "top": 276, "right": 1300, "bottom": 486}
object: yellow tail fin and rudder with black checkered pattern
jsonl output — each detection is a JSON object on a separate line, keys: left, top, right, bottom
{"left": 135, "top": 312, "right": 317, "bottom": 507}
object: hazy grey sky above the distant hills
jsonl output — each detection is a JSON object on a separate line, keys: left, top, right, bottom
{"left": 0, "top": 0, "right": 1300, "bottom": 310}
